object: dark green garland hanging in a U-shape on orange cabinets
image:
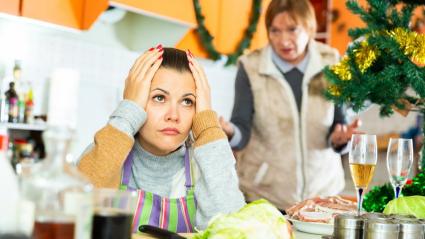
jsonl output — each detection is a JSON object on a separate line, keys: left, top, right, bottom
{"left": 193, "top": 0, "right": 261, "bottom": 66}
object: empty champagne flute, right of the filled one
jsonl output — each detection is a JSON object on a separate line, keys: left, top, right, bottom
{"left": 387, "top": 138, "right": 413, "bottom": 198}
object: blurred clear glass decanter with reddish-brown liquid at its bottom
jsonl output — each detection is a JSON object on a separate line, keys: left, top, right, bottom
{"left": 22, "top": 126, "right": 93, "bottom": 239}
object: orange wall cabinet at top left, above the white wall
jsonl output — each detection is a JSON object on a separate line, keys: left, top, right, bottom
{"left": 20, "top": 0, "right": 108, "bottom": 30}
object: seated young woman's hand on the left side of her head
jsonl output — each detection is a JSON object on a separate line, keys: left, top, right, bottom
{"left": 124, "top": 45, "right": 164, "bottom": 110}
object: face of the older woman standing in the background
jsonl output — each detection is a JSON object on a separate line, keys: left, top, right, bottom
{"left": 268, "top": 12, "right": 310, "bottom": 65}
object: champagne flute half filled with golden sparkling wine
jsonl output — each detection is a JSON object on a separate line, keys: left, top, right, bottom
{"left": 348, "top": 134, "right": 378, "bottom": 215}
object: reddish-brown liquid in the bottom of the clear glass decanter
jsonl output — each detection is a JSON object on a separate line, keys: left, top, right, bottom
{"left": 33, "top": 221, "right": 75, "bottom": 239}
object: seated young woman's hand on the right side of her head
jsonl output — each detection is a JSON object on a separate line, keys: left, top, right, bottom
{"left": 186, "top": 50, "right": 211, "bottom": 113}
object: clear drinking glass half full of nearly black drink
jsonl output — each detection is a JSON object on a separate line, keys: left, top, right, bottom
{"left": 92, "top": 188, "right": 138, "bottom": 239}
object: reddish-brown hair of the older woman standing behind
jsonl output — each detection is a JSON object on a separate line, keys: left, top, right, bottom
{"left": 266, "top": 0, "right": 317, "bottom": 38}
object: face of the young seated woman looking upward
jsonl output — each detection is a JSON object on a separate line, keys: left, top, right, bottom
{"left": 139, "top": 67, "right": 195, "bottom": 156}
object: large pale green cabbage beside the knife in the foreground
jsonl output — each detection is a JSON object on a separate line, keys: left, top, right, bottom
{"left": 194, "top": 199, "right": 295, "bottom": 239}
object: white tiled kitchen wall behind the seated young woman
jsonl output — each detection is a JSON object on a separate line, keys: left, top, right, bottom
{"left": 0, "top": 16, "right": 235, "bottom": 157}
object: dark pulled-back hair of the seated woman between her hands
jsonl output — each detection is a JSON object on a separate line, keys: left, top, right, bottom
{"left": 161, "top": 47, "right": 190, "bottom": 72}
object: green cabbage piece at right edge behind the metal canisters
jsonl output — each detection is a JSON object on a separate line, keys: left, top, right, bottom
{"left": 384, "top": 196, "right": 425, "bottom": 219}
